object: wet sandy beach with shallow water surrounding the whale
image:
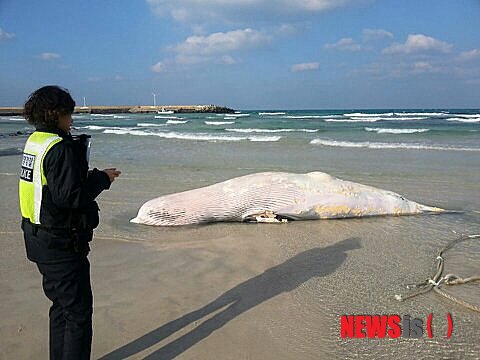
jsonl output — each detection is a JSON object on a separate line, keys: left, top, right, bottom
{"left": 0, "top": 112, "right": 480, "bottom": 360}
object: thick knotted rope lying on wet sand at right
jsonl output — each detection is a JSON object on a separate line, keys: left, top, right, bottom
{"left": 395, "top": 235, "right": 480, "bottom": 312}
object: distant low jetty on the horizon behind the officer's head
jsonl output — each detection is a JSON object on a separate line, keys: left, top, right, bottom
{"left": 0, "top": 105, "right": 235, "bottom": 116}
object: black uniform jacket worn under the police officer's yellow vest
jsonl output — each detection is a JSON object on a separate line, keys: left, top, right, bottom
{"left": 22, "top": 128, "right": 110, "bottom": 263}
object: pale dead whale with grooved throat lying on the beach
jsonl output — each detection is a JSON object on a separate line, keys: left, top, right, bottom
{"left": 131, "top": 171, "right": 444, "bottom": 226}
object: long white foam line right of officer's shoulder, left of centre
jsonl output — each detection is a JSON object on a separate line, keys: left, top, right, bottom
{"left": 104, "top": 129, "right": 281, "bottom": 142}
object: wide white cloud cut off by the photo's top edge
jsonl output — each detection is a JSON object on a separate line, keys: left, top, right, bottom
{"left": 146, "top": 0, "right": 371, "bottom": 23}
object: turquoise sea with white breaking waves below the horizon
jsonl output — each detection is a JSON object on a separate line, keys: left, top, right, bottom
{"left": 0, "top": 109, "right": 480, "bottom": 151}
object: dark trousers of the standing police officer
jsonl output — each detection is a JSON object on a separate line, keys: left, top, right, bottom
{"left": 37, "top": 256, "right": 93, "bottom": 360}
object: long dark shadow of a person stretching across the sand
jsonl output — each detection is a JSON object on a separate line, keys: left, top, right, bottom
{"left": 101, "top": 238, "right": 360, "bottom": 360}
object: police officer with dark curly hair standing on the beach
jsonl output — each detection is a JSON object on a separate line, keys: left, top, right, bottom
{"left": 19, "top": 86, "right": 120, "bottom": 359}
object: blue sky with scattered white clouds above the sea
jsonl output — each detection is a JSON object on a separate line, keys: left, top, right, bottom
{"left": 0, "top": 0, "right": 480, "bottom": 109}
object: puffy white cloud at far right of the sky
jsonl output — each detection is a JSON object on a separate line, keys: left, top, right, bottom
{"left": 383, "top": 34, "right": 452, "bottom": 54}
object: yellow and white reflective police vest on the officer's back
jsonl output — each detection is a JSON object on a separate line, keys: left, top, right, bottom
{"left": 18, "top": 131, "right": 63, "bottom": 225}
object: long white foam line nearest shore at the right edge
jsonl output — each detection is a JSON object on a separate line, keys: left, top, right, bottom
{"left": 310, "top": 139, "right": 480, "bottom": 151}
